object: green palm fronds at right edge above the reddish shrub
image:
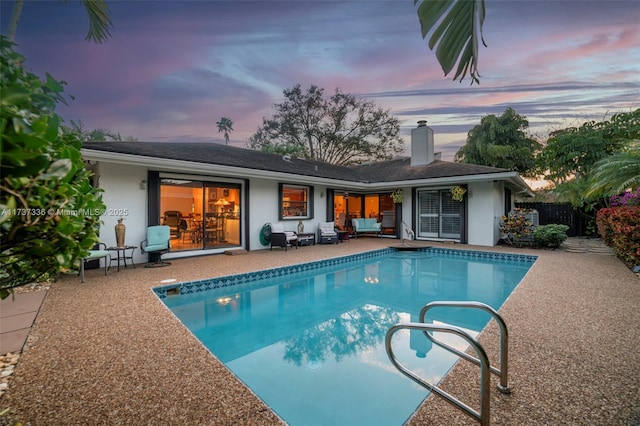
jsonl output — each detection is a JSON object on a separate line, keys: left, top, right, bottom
{"left": 587, "top": 139, "right": 640, "bottom": 197}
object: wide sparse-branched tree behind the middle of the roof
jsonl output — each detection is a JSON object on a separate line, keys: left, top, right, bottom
{"left": 249, "top": 84, "right": 402, "bottom": 165}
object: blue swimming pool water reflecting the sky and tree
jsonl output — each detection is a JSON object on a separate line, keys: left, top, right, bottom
{"left": 154, "top": 248, "right": 536, "bottom": 426}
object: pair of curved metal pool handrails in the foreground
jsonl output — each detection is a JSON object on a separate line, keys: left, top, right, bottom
{"left": 385, "top": 301, "right": 510, "bottom": 426}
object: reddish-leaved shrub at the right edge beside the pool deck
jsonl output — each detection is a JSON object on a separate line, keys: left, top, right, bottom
{"left": 596, "top": 206, "right": 640, "bottom": 267}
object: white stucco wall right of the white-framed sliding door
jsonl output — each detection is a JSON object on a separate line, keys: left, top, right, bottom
{"left": 467, "top": 182, "right": 502, "bottom": 246}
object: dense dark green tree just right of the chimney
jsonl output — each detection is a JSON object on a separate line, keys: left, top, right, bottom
{"left": 455, "top": 108, "right": 542, "bottom": 176}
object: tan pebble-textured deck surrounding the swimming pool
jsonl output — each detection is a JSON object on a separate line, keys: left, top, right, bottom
{"left": 0, "top": 238, "right": 640, "bottom": 425}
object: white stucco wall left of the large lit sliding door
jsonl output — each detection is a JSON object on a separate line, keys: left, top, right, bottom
{"left": 97, "top": 162, "right": 148, "bottom": 263}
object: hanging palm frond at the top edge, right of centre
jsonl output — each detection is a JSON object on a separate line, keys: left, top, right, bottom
{"left": 413, "top": 0, "right": 487, "bottom": 84}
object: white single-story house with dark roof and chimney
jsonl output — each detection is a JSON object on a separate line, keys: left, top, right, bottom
{"left": 82, "top": 121, "right": 532, "bottom": 262}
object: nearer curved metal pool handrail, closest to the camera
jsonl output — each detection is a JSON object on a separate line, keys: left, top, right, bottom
{"left": 385, "top": 322, "right": 491, "bottom": 426}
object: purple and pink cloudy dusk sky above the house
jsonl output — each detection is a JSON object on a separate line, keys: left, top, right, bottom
{"left": 0, "top": 0, "right": 640, "bottom": 160}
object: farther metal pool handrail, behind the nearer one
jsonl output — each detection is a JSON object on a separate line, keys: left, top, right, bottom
{"left": 420, "top": 300, "right": 511, "bottom": 394}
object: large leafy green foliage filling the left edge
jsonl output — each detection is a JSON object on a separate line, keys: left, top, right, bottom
{"left": 0, "top": 36, "right": 104, "bottom": 298}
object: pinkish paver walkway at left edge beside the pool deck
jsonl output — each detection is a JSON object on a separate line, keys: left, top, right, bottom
{"left": 0, "top": 290, "right": 47, "bottom": 355}
